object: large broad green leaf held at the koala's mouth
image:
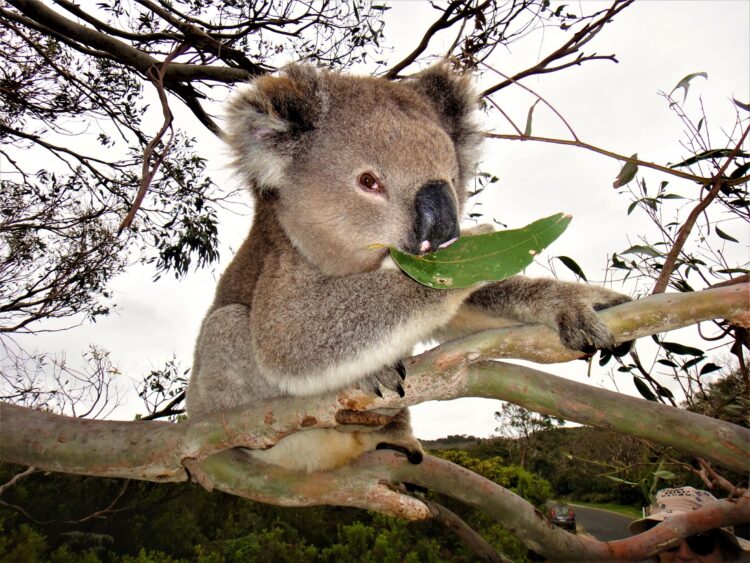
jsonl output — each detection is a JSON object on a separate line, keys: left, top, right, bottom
{"left": 390, "top": 213, "right": 571, "bottom": 289}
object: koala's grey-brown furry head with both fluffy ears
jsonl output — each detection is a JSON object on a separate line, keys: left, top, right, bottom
{"left": 226, "top": 64, "right": 481, "bottom": 275}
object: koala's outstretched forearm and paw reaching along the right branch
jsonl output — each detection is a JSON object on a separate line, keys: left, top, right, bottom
{"left": 466, "top": 276, "right": 631, "bottom": 353}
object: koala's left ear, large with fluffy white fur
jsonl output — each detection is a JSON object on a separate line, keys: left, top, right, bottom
{"left": 224, "top": 65, "right": 326, "bottom": 191}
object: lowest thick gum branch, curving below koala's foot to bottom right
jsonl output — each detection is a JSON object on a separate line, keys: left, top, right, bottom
{"left": 201, "top": 451, "right": 750, "bottom": 561}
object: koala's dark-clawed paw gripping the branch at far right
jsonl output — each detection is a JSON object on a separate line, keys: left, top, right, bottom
{"left": 556, "top": 286, "right": 633, "bottom": 356}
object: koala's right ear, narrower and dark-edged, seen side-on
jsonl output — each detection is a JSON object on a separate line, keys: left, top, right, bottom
{"left": 407, "top": 62, "right": 483, "bottom": 181}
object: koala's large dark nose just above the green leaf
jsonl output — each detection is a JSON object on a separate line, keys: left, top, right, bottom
{"left": 411, "top": 182, "right": 459, "bottom": 254}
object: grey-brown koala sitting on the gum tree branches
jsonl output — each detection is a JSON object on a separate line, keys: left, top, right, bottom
{"left": 187, "top": 63, "right": 629, "bottom": 472}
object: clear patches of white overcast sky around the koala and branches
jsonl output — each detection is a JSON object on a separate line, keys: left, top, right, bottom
{"left": 8, "top": 0, "right": 750, "bottom": 439}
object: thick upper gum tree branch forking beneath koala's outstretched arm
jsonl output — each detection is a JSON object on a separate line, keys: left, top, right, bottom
{"left": 0, "top": 284, "right": 750, "bottom": 481}
